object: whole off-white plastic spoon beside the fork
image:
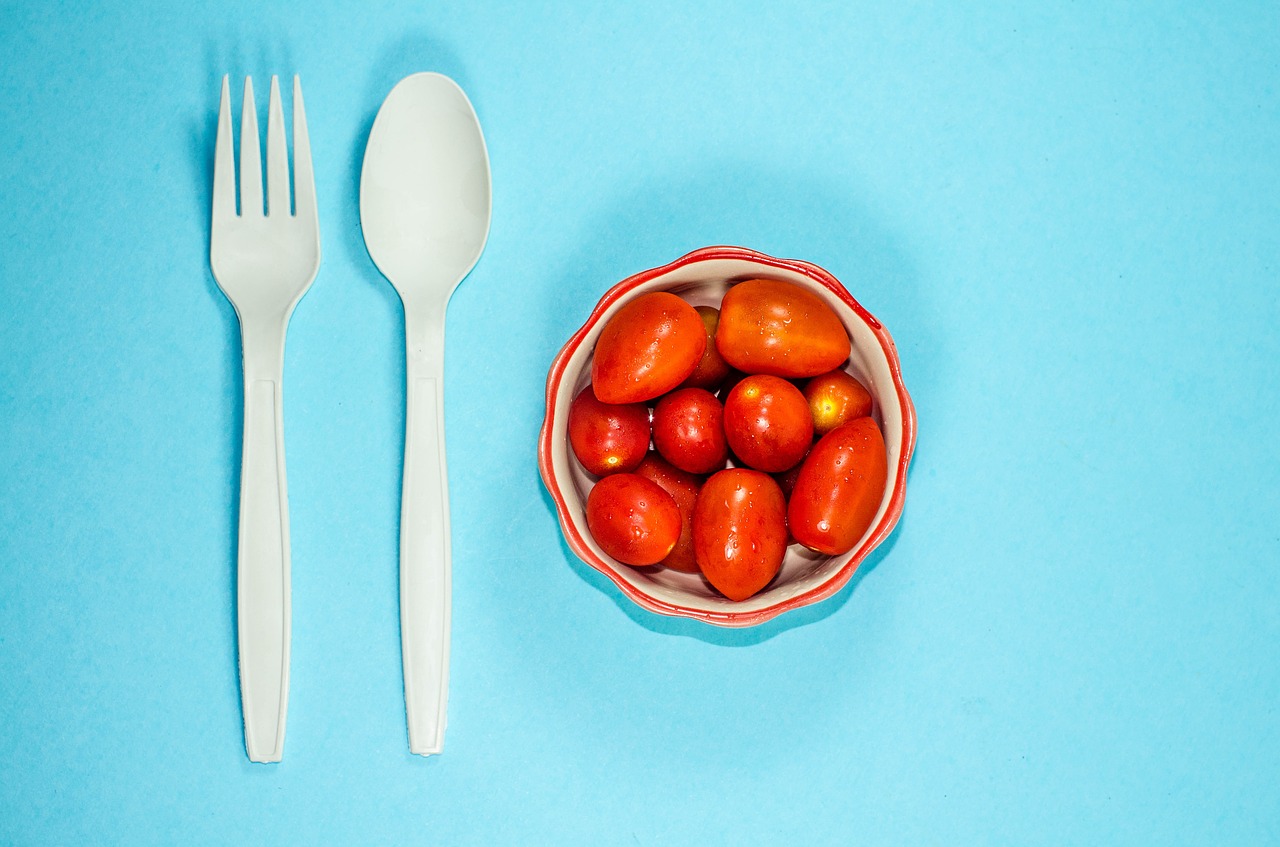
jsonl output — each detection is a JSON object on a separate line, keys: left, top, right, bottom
{"left": 360, "top": 73, "right": 490, "bottom": 756}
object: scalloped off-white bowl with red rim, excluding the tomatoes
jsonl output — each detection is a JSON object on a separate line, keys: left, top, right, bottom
{"left": 538, "top": 247, "right": 915, "bottom": 627}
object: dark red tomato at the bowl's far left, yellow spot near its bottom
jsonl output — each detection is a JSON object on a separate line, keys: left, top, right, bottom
{"left": 568, "top": 385, "right": 649, "bottom": 476}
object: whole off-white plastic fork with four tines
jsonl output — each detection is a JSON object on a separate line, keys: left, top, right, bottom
{"left": 209, "top": 77, "right": 320, "bottom": 761}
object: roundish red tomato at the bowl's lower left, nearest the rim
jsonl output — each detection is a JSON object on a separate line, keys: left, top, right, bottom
{"left": 586, "top": 473, "right": 680, "bottom": 567}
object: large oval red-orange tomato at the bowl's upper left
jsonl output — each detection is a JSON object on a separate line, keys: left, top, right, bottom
{"left": 591, "top": 292, "right": 707, "bottom": 403}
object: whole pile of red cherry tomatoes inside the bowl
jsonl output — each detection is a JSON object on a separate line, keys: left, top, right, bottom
{"left": 568, "top": 279, "right": 887, "bottom": 600}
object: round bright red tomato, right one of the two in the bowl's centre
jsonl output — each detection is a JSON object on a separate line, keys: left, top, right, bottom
{"left": 724, "top": 375, "right": 813, "bottom": 473}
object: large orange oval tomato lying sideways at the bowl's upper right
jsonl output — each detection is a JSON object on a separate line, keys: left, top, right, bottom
{"left": 716, "top": 279, "right": 850, "bottom": 379}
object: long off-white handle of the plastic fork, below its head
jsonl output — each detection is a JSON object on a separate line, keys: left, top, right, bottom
{"left": 236, "top": 317, "right": 289, "bottom": 763}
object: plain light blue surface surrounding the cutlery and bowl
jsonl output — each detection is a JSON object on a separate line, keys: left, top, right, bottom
{"left": 0, "top": 0, "right": 1280, "bottom": 844}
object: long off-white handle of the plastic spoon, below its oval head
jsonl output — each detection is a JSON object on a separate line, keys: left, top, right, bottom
{"left": 401, "top": 308, "right": 451, "bottom": 756}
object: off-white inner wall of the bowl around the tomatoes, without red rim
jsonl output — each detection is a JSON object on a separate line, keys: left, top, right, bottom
{"left": 552, "top": 258, "right": 902, "bottom": 614}
